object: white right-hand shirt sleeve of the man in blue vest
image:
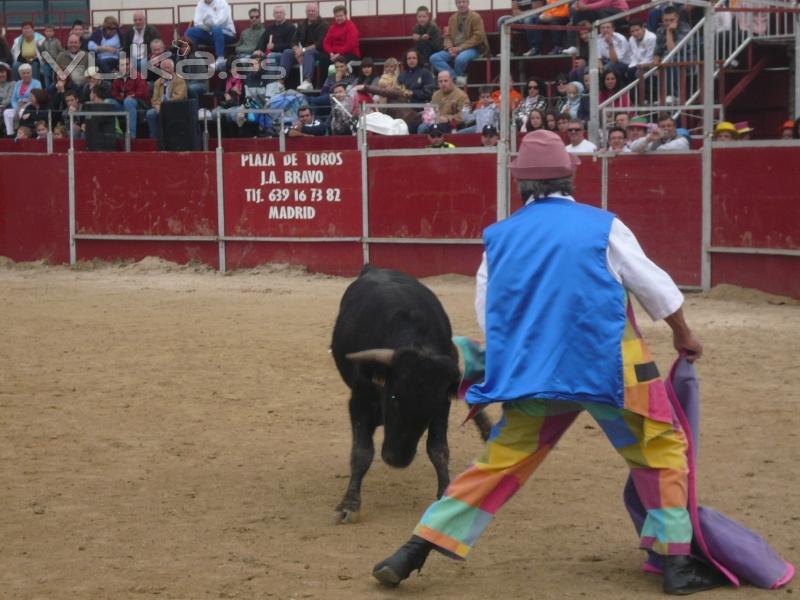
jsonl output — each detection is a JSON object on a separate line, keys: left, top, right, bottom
{"left": 606, "top": 219, "right": 683, "bottom": 321}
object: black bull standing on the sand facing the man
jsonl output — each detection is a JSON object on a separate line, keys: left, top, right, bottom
{"left": 331, "top": 265, "right": 490, "bottom": 523}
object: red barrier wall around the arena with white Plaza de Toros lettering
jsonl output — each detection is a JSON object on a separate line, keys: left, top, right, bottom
{"left": 0, "top": 149, "right": 800, "bottom": 297}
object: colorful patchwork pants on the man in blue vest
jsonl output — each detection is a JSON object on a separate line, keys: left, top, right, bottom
{"left": 414, "top": 399, "right": 692, "bottom": 558}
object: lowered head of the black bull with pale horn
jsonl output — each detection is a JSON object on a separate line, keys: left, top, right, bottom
{"left": 347, "top": 348, "right": 461, "bottom": 467}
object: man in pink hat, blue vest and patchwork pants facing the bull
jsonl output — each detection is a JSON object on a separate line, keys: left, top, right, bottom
{"left": 372, "top": 130, "right": 725, "bottom": 595}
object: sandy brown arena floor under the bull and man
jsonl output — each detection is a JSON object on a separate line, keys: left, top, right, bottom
{"left": 0, "top": 259, "right": 800, "bottom": 600}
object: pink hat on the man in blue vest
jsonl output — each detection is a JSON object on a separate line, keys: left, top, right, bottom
{"left": 511, "top": 129, "right": 581, "bottom": 181}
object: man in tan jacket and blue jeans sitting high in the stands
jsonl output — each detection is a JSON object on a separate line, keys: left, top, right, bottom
{"left": 431, "top": 0, "right": 489, "bottom": 86}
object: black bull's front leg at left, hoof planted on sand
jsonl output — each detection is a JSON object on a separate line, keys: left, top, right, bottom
{"left": 334, "top": 392, "right": 378, "bottom": 523}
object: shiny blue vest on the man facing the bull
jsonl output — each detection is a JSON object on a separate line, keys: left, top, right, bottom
{"left": 466, "top": 198, "right": 626, "bottom": 408}
